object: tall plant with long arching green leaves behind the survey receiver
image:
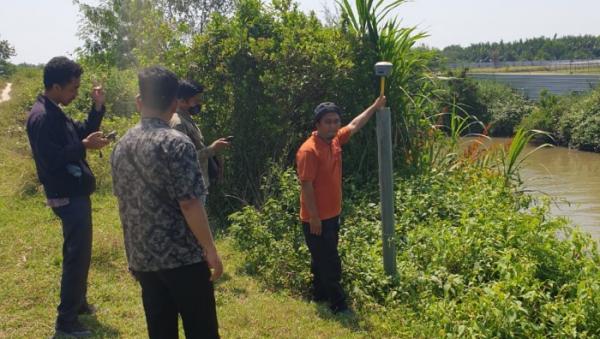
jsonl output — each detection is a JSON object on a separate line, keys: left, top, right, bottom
{"left": 338, "top": 0, "right": 431, "bottom": 173}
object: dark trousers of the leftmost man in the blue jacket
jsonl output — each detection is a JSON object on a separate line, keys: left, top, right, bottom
{"left": 52, "top": 196, "right": 92, "bottom": 325}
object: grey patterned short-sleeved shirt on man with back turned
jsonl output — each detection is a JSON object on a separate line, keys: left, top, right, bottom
{"left": 111, "top": 118, "right": 206, "bottom": 272}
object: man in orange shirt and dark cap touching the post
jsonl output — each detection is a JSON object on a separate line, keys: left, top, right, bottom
{"left": 296, "top": 96, "right": 385, "bottom": 313}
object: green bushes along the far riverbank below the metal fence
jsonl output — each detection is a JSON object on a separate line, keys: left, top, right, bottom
{"left": 440, "top": 71, "right": 600, "bottom": 152}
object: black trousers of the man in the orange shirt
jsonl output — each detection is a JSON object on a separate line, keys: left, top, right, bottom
{"left": 302, "top": 216, "right": 347, "bottom": 312}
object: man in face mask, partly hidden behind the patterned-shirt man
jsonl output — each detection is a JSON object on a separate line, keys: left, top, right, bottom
{"left": 169, "top": 80, "right": 229, "bottom": 204}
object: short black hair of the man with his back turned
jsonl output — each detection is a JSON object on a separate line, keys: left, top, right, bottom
{"left": 138, "top": 66, "right": 179, "bottom": 112}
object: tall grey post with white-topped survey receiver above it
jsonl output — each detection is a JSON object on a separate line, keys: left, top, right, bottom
{"left": 375, "top": 62, "right": 397, "bottom": 276}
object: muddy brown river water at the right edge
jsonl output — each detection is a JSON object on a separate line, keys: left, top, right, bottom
{"left": 474, "top": 138, "right": 600, "bottom": 239}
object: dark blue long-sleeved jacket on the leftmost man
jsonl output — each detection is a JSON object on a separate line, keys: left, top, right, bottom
{"left": 27, "top": 95, "right": 105, "bottom": 199}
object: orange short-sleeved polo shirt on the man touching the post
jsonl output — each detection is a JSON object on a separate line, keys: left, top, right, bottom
{"left": 296, "top": 127, "right": 351, "bottom": 222}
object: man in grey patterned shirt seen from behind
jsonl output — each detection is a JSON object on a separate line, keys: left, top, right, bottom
{"left": 111, "top": 67, "right": 223, "bottom": 338}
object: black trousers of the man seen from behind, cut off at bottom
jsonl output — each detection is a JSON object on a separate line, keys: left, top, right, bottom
{"left": 134, "top": 262, "right": 219, "bottom": 339}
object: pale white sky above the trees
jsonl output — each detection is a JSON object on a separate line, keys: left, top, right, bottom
{"left": 0, "top": 0, "right": 600, "bottom": 63}
